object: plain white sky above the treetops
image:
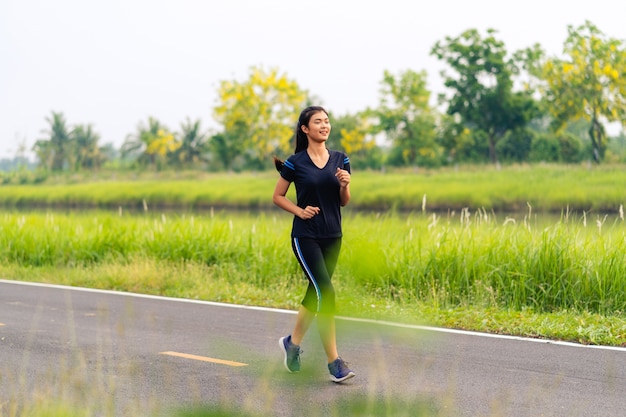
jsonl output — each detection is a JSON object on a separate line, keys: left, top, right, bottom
{"left": 0, "top": 0, "right": 626, "bottom": 158}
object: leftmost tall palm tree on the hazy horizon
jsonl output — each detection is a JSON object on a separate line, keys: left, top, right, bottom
{"left": 33, "top": 112, "right": 72, "bottom": 171}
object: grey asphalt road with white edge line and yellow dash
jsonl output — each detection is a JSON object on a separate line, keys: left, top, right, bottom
{"left": 0, "top": 280, "right": 626, "bottom": 417}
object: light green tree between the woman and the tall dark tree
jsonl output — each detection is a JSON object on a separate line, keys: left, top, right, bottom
{"left": 374, "top": 70, "right": 441, "bottom": 165}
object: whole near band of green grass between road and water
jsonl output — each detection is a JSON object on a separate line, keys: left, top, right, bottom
{"left": 0, "top": 210, "right": 626, "bottom": 344}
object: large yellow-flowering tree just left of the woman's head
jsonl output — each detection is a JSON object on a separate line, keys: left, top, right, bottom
{"left": 214, "top": 67, "right": 308, "bottom": 165}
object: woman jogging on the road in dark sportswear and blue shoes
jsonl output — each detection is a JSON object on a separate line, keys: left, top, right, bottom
{"left": 272, "top": 106, "right": 355, "bottom": 382}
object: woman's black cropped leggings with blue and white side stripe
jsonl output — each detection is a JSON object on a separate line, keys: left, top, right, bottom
{"left": 291, "top": 237, "right": 341, "bottom": 314}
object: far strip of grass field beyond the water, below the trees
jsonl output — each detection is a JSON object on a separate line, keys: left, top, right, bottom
{"left": 0, "top": 165, "right": 626, "bottom": 214}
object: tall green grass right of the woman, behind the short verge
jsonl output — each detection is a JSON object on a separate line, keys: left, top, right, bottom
{"left": 348, "top": 212, "right": 626, "bottom": 314}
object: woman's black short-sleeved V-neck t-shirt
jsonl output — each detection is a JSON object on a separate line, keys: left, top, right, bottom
{"left": 280, "top": 150, "right": 350, "bottom": 239}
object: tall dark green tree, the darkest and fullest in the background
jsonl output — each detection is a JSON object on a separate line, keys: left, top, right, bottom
{"left": 431, "top": 29, "right": 537, "bottom": 163}
